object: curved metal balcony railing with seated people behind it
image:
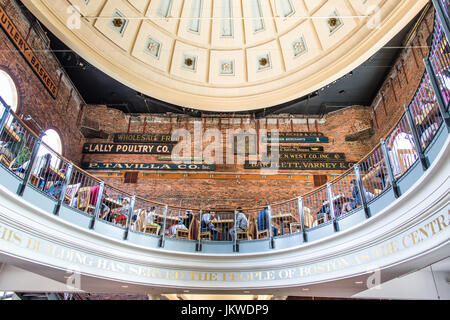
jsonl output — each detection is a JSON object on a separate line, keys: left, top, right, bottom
{"left": 0, "top": 0, "right": 450, "bottom": 251}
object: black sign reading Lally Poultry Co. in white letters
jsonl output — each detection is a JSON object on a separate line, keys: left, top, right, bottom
{"left": 83, "top": 143, "right": 173, "bottom": 154}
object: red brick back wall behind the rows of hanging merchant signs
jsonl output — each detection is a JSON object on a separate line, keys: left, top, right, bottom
{"left": 82, "top": 105, "right": 372, "bottom": 206}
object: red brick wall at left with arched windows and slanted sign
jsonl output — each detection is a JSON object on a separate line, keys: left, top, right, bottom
{"left": 0, "top": 0, "right": 84, "bottom": 163}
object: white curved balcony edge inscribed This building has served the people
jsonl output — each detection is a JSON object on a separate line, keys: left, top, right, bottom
{"left": 0, "top": 132, "right": 450, "bottom": 290}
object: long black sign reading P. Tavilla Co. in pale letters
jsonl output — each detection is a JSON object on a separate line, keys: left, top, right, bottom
{"left": 82, "top": 162, "right": 216, "bottom": 171}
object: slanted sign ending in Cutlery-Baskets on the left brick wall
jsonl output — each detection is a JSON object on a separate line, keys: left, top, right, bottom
{"left": 0, "top": 5, "right": 58, "bottom": 99}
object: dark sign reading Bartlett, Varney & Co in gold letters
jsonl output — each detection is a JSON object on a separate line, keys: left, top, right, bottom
{"left": 244, "top": 161, "right": 355, "bottom": 170}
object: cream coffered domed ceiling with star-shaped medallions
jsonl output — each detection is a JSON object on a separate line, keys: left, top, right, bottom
{"left": 22, "top": 0, "right": 428, "bottom": 111}
